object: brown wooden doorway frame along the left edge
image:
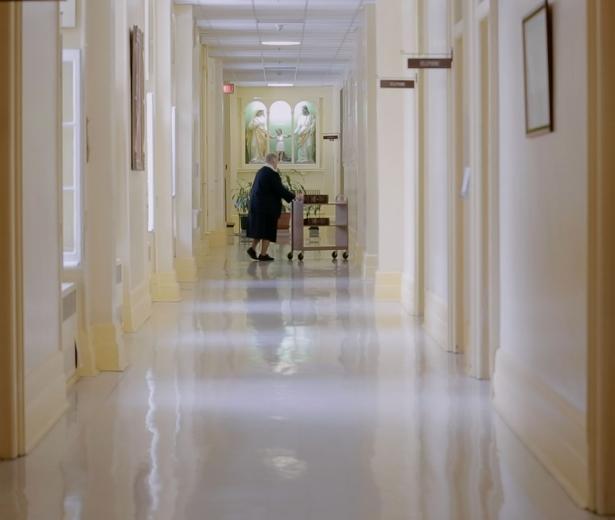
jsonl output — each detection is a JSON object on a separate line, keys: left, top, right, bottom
{"left": 0, "top": 2, "right": 25, "bottom": 459}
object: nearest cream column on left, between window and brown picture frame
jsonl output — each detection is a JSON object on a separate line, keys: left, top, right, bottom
{"left": 85, "top": 0, "right": 127, "bottom": 370}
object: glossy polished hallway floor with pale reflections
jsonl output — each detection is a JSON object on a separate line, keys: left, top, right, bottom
{"left": 0, "top": 239, "right": 608, "bottom": 520}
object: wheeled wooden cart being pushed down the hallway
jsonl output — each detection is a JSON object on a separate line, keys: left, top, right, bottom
{"left": 287, "top": 196, "right": 349, "bottom": 261}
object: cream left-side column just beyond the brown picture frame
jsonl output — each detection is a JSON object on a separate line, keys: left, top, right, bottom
{"left": 151, "top": 0, "right": 181, "bottom": 302}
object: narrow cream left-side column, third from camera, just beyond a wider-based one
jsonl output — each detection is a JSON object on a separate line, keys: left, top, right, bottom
{"left": 174, "top": 5, "right": 200, "bottom": 282}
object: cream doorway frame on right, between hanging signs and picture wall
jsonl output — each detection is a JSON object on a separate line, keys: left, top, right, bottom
{"left": 448, "top": 0, "right": 500, "bottom": 379}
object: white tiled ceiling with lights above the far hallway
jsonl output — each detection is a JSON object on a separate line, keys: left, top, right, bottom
{"left": 176, "top": 0, "right": 375, "bottom": 86}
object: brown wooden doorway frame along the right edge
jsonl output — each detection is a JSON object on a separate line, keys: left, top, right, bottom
{"left": 587, "top": 0, "right": 615, "bottom": 515}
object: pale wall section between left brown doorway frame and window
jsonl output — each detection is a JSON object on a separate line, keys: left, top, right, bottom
{"left": 22, "top": 3, "right": 67, "bottom": 449}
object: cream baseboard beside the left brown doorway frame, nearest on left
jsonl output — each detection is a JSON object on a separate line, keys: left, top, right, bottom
{"left": 25, "top": 350, "right": 68, "bottom": 453}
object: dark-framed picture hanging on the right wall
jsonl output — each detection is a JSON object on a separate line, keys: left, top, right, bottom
{"left": 523, "top": 0, "right": 553, "bottom": 135}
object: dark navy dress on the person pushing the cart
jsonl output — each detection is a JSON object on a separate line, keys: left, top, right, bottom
{"left": 248, "top": 166, "right": 295, "bottom": 242}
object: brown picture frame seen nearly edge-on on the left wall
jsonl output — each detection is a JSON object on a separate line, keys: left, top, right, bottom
{"left": 130, "top": 25, "right": 145, "bottom": 171}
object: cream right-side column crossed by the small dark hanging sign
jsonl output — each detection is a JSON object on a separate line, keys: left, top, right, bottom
{"left": 376, "top": 0, "right": 417, "bottom": 300}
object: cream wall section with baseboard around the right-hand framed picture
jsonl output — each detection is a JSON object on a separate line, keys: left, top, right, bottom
{"left": 495, "top": 0, "right": 588, "bottom": 504}
